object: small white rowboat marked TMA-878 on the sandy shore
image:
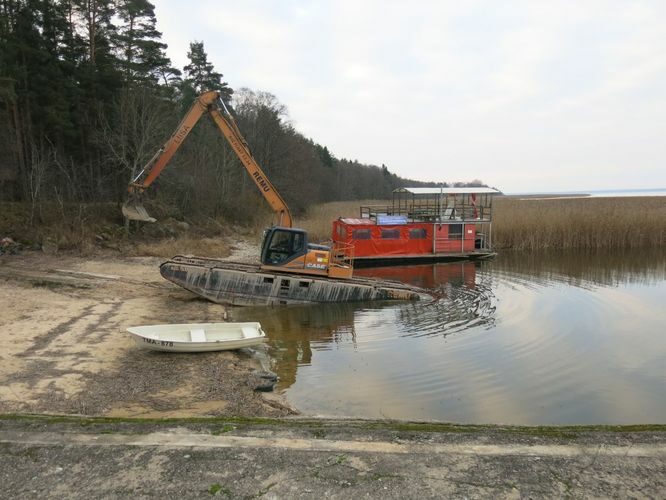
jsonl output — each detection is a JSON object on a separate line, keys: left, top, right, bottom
{"left": 127, "top": 322, "right": 266, "bottom": 352}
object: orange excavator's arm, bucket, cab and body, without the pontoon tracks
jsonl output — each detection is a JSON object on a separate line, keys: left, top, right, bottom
{"left": 122, "top": 91, "right": 353, "bottom": 278}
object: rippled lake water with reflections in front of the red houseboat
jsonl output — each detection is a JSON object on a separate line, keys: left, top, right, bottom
{"left": 234, "top": 251, "right": 666, "bottom": 425}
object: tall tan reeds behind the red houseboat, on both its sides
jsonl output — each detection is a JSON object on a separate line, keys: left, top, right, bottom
{"left": 296, "top": 196, "right": 666, "bottom": 250}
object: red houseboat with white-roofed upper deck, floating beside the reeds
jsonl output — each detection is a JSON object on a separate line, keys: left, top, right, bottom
{"left": 333, "top": 187, "right": 499, "bottom": 267}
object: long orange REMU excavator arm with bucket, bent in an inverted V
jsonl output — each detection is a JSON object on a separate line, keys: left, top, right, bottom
{"left": 122, "top": 91, "right": 293, "bottom": 228}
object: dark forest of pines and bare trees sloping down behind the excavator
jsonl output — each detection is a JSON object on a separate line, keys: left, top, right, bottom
{"left": 0, "top": 0, "right": 480, "bottom": 223}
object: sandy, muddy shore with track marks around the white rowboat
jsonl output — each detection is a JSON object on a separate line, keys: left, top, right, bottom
{"left": 0, "top": 252, "right": 294, "bottom": 417}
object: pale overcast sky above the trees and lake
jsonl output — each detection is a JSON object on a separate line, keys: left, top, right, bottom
{"left": 153, "top": 0, "right": 666, "bottom": 192}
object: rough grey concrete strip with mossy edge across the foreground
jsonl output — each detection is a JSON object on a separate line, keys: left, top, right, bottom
{"left": 0, "top": 416, "right": 666, "bottom": 499}
